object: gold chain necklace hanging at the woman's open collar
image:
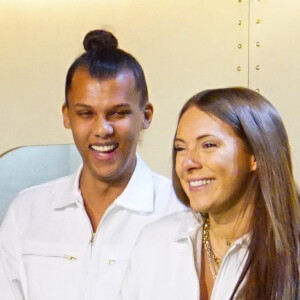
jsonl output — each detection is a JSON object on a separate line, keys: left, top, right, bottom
{"left": 202, "top": 217, "right": 222, "bottom": 279}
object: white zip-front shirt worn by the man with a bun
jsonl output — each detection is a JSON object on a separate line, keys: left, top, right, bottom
{"left": 0, "top": 158, "right": 184, "bottom": 300}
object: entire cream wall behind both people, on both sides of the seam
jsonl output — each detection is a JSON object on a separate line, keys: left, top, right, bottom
{"left": 0, "top": 0, "right": 300, "bottom": 182}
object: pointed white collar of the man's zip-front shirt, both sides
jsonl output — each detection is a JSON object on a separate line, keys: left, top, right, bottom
{"left": 53, "top": 155, "right": 154, "bottom": 212}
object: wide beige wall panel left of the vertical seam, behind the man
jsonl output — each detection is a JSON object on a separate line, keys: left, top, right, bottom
{"left": 0, "top": 0, "right": 248, "bottom": 174}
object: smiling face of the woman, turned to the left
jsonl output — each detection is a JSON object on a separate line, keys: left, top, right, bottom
{"left": 174, "top": 106, "right": 256, "bottom": 214}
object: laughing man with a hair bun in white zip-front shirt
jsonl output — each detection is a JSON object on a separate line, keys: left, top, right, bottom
{"left": 0, "top": 30, "right": 183, "bottom": 300}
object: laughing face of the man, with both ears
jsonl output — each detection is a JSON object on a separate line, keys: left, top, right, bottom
{"left": 63, "top": 68, "right": 153, "bottom": 185}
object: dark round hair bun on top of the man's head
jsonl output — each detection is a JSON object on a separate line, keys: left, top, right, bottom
{"left": 83, "top": 30, "right": 118, "bottom": 52}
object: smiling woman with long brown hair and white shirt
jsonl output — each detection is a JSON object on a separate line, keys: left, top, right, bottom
{"left": 120, "top": 88, "right": 300, "bottom": 300}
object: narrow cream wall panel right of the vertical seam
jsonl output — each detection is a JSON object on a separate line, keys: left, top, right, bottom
{"left": 249, "top": 0, "right": 300, "bottom": 183}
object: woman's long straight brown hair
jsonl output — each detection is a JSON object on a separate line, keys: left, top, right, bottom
{"left": 172, "top": 88, "right": 300, "bottom": 300}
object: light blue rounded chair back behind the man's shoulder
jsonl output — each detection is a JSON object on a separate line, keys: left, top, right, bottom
{"left": 0, "top": 145, "right": 81, "bottom": 224}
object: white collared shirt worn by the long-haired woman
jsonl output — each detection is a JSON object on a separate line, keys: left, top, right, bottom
{"left": 118, "top": 210, "right": 248, "bottom": 300}
